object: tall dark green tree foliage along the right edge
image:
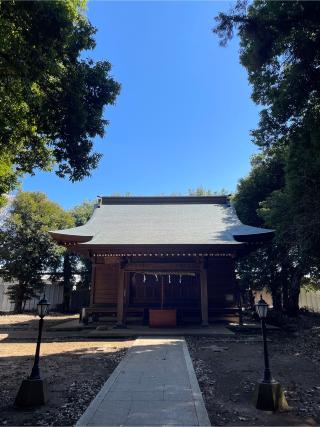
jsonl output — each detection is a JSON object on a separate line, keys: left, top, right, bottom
{"left": 214, "top": 0, "right": 320, "bottom": 314}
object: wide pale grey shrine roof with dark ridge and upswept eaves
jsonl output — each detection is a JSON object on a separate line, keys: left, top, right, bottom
{"left": 51, "top": 196, "right": 273, "bottom": 247}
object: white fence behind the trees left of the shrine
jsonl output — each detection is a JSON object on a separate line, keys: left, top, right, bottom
{"left": 0, "top": 278, "right": 63, "bottom": 312}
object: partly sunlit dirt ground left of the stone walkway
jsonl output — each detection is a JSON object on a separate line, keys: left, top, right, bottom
{"left": 0, "top": 315, "right": 132, "bottom": 426}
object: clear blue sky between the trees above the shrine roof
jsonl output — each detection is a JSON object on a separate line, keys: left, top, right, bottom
{"left": 23, "top": 1, "right": 258, "bottom": 208}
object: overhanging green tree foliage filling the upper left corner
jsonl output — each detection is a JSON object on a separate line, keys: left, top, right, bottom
{"left": 0, "top": 0, "right": 119, "bottom": 195}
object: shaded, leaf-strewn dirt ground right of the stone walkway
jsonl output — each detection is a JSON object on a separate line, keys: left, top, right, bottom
{"left": 187, "top": 322, "right": 320, "bottom": 426}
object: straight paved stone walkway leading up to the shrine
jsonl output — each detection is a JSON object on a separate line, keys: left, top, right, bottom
{"left": 76, "top": 337, "right": 210, "bottom": 426}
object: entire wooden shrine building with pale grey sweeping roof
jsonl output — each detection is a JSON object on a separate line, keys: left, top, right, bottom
{"left": 51, "top": 196, "right": 273, "bottom": 327}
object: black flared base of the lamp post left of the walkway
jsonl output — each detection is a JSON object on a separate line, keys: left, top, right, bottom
{"left": 14, "top": 378, "right": 48, "bottom": 407}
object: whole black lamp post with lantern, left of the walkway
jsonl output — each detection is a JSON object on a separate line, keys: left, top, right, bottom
{"left": 15, "top": 296, "right": 50, "bottom": 407}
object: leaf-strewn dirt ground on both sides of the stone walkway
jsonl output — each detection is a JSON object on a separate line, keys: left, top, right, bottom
{"left": 0, "top": 315, "right": 320, "bottom": 426}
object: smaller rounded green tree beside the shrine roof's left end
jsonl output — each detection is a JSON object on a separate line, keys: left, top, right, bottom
{"left": 0, "top": 192, "right": 73, "bottom": 312}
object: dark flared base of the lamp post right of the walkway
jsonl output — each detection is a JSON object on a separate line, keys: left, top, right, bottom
{"left": 253, "top": 381, "right": 289, "bottom": 411}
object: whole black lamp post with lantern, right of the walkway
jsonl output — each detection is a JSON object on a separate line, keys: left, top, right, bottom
{"left": 254, "top": 295, "right": 288, "bottom": 411}
